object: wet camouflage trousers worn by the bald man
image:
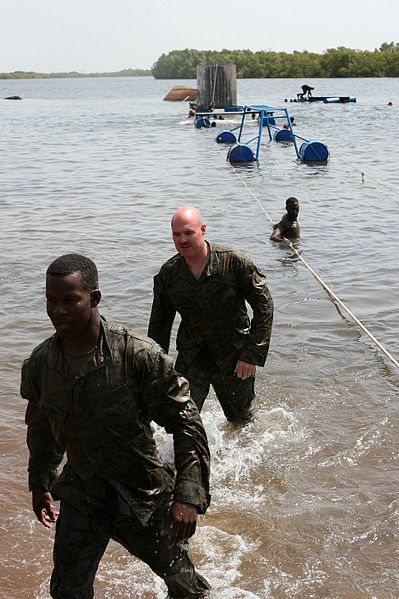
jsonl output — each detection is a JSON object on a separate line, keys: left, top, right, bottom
{"left": 176, "top": 348, "right": 255, "bottom": 422}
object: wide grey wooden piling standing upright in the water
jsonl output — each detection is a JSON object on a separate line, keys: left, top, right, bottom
{"left": 197, "top": 64, "right": 237, "bottom": 108}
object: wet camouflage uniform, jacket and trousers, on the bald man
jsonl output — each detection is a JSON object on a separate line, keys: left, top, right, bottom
{"left": 148, "top": 242, "right": 273, "bottom": 421}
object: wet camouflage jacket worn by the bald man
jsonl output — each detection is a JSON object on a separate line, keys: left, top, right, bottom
{"left": 148, "top": 242, "right": 273, "bottom": 367}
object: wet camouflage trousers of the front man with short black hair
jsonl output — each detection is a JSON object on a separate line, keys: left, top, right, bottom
{"left": 50, "top": 501, "right": 210, "bottom": 599}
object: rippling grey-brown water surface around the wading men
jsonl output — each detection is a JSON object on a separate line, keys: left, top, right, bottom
{"left": 0, "top": 78, "right": 399, "bottom": 599}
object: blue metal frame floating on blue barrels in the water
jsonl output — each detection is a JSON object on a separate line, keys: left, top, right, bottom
{"left": 194, "top": 104, "right": 329, "bottom": 163}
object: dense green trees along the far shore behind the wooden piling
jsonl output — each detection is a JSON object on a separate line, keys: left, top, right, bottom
{"left": 151, "top": 42, "right": 399, "bottom": 79}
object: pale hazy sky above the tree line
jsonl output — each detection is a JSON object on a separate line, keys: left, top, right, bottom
{"left": 0, "top": 0, "right": 399, "bottom": 72}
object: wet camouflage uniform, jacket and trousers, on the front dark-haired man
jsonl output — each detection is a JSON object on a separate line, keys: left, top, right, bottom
{"left": 21, "top": 321, "right": 210, "bottom": 599}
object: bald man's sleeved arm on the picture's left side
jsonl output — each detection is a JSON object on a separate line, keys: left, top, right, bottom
{"left": 148, "top": 274, "right": 176, "bottom": 352}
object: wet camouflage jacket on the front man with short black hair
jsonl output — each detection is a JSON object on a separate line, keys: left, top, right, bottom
{"left": 21, "top": 320, "right": 210, "bottom": 524}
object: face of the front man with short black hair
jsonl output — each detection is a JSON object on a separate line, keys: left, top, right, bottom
{"left": 46, "top": 272, "right": 93, "bottom": 338}
